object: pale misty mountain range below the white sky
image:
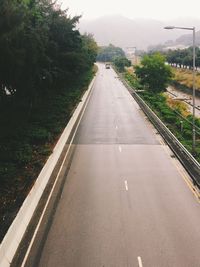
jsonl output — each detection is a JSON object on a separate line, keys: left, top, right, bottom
{"left": 79, "top": 15, "right": 200, "bottom": 49}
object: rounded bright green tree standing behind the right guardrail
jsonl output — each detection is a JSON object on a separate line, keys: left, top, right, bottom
{"left": 135, "top": 53, "right": 173, "bottom": 92}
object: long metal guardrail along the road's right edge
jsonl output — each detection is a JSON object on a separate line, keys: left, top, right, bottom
{"left": 118, "top": 73, "right": 200, "bottom": 188}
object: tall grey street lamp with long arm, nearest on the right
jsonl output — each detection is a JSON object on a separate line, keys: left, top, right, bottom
{"left": 164, "top": 26, "right": 196, "bottom": 154}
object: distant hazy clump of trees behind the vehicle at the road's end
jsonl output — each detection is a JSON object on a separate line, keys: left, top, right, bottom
{"left": 97, "top": 44, "right": 125, "bottom": 62}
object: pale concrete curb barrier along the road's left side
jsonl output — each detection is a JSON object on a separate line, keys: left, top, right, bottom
{"left": 0, "top": 76, "right": 96, "bottom": 267}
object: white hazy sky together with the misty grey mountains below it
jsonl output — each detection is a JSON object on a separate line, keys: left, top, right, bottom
{"left": 58, "top": 0, "right": 200, "bottom": 50}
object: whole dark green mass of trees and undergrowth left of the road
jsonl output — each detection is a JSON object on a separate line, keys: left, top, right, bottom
{"left": 0, "top": 0, "right": 97, "bottom": 240}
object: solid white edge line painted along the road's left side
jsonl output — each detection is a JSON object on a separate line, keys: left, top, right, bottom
{"left": 21, "top": 76, "right": 94, "bottom": 267}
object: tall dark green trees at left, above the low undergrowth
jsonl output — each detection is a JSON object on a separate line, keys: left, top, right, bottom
{"left": 0, "top": 0, "right": 97, "bottom": 103}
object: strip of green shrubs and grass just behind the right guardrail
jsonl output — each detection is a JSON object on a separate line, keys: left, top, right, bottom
{"left": 124, "top": 55, "right": 200, "bottom": 162}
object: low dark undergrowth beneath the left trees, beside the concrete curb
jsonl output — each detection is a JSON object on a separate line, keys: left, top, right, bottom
{"left": 0, "top": 67, "right": 97, "bottom": 241}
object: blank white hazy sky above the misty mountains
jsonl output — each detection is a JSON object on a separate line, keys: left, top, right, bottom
{"left": 58, "top": 0, "right": 200, "bottom": 20}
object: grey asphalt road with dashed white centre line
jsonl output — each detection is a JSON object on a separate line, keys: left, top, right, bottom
{"left": 23, "top": 64, "right": 200, "bottom": 267}
